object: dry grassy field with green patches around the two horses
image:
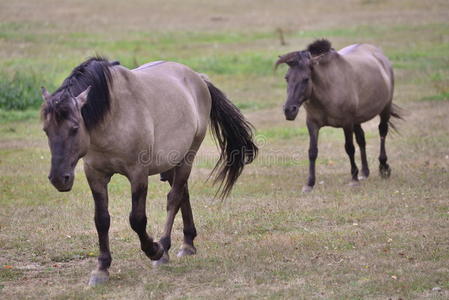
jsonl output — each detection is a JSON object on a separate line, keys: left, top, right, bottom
{"left": 0, "top": 0, "right": 449, "bottom": 299}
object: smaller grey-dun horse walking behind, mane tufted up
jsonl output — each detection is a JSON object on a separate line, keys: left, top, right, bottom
{"left": 275, "top": 39, "right": 402, "bottom": 192}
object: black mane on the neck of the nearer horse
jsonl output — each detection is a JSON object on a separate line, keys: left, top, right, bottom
{"left": 43, "top": 57, "right": 114, "bottom": 130}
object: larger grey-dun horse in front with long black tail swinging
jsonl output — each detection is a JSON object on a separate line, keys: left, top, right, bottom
{"left": 41, "top": 57, "right": 258, "bottom": 286}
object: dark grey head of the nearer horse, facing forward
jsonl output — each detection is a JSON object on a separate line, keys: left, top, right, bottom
{"left": 42, "top": 87, "right": 90, "bottom": 192}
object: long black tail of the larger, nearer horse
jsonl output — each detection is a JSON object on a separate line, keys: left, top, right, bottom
{"left": 205, "top": 80, "right": 258, "bottom": 198}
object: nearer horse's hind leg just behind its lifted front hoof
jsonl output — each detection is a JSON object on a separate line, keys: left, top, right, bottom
{"left": 153, "top": 162, "right": 194, "bottom": 266}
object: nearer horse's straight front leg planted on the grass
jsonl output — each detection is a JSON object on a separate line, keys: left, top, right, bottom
{"left": 84, "top": 164, "right": 112, "bottom": 286}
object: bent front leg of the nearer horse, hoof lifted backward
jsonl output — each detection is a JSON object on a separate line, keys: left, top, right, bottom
{"left": 129, "top": 173, "right": 164, "bottom": 260}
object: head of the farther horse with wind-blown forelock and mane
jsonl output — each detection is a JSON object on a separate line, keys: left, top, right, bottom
{"left": 276, "top": 39, "right": 331, "bottom": 121}
